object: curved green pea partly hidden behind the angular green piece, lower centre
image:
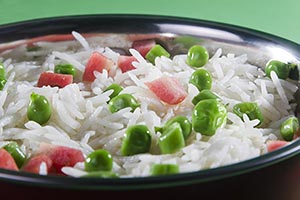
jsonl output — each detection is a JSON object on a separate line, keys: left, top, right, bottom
{"left": 164, "top": 116, "right": 192, "bottom": 140}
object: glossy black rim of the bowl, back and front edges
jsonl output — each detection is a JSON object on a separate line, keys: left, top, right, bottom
{"left": 0, "top": 14, "right": 300, "bottom": 190}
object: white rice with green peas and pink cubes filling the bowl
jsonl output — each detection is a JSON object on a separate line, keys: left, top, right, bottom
{"left": 0, "top": 32, "right": 299, "bottom": 177}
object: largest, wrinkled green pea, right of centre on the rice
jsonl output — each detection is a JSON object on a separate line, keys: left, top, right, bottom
{"left": 192, "top": 99, "right": 227, "bottom": 136}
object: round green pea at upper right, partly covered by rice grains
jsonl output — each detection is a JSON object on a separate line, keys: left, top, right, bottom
{"left": 265, "top": 60, "right": 290, "bottom": 79}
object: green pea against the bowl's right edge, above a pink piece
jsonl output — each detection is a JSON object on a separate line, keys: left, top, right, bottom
{"left": 280, "top": 117, "right": 299, "bottom": 141}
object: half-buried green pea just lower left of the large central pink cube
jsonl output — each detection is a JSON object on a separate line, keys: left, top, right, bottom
{"left": 108, "top": 94, "right": 140, "bottom": 113}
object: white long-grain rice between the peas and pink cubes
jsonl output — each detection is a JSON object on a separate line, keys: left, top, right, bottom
{"left": 0, "top": 32, "right": 298, "bottom": 177}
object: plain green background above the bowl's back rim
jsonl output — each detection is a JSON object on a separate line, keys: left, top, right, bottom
{"left": 0, "top": 0, "right": 300, "bottom": 43}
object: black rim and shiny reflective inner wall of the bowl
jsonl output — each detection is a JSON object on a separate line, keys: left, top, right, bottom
{"left": 0, "top": 15, "right": 300, "bottom": 191}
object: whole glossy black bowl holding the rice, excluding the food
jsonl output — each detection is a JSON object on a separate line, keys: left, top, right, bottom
{"left": 0, "top": 15, "right": 300, "bottom": 199}
